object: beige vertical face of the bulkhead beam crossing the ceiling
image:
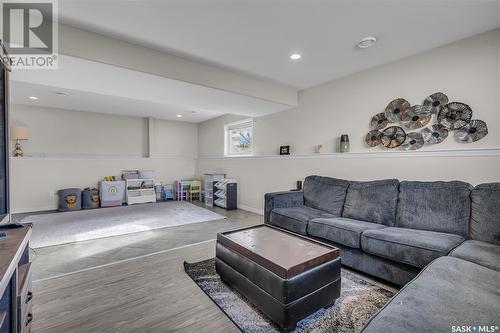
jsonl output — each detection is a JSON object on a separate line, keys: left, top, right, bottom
{"left": 58, "top": 23, "right": 297, "bottom": 105}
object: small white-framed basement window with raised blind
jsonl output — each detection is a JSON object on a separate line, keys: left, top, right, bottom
{"left": 224, "top": 119, "right": 253, "bottom": 156}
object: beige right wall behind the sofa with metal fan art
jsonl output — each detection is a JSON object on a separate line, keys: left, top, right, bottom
{"left": 196, "top": 29, "right": 500, "bottom": 210}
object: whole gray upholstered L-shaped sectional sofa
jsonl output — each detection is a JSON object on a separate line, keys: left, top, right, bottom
{"left": 265, "top": 176, "right": 500, "bottom": 333}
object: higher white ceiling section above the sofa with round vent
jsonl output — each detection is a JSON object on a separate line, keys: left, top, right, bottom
{"left": 55, "top": 0, "right": 500, "bottom": 89}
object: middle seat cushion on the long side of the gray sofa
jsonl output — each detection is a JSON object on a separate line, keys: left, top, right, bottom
{"left": 307, "top": 217, "right": 385, "bottom": 249}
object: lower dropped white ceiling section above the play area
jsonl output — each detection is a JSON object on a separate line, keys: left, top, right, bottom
{"left": 11, "top": 54, "right": 290, "bottom": 122}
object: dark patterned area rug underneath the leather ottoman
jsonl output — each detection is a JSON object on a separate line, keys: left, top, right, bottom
{"left": 184, "top": 259, "right": 395, "bottom": 333}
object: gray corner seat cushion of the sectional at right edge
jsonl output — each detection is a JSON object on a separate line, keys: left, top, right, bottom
{"left": 450, "top": 240, "right": 500, "bottom": 271}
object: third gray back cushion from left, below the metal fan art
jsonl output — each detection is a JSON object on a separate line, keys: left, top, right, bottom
{"left": 395, "top": 181, "right": 472, "bottom": 237}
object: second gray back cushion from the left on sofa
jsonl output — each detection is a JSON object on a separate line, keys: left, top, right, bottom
{"left": 342, "top": 179, "right": 399, "bottom": 227}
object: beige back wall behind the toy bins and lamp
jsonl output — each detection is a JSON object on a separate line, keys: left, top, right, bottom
{"left": 10, "top": 104, "right": 197, "bottom": 212}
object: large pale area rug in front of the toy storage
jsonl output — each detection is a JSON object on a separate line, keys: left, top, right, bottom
{"left": 21, "top": 201, "right": 225, "bottom": 248}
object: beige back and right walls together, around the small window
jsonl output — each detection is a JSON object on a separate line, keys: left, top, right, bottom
{"left": 11, "top": 30, "right": 500, "bottom": 212}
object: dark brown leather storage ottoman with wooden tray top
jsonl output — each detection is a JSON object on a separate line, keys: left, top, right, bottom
{"left": 215, "top": 225, "right": 340, "bottom": 331}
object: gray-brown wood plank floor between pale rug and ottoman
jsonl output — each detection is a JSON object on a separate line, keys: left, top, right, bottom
{"left": 16, "top": 204, "right": 263, "bottom": 333}
